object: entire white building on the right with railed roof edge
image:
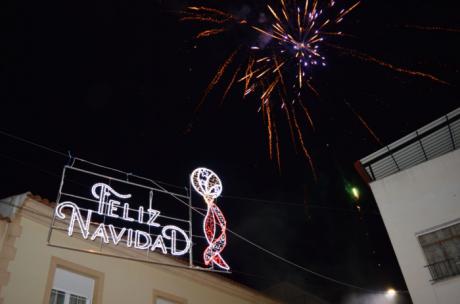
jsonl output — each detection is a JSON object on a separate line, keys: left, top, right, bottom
{"left": 357, "top": 105, "right": 460, "bottom": 304}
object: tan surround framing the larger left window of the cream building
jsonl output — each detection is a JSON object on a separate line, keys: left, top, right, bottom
{"left": 43, "top": 256, "right": 104, "bottom": 304}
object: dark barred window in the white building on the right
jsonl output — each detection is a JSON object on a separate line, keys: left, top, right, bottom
{"left": 418, "top": 223, "right": 460, "bottom": 281}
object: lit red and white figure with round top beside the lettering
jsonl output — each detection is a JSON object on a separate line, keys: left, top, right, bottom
{"left": 190, "top": 168, "right": 230, "bottom": 270}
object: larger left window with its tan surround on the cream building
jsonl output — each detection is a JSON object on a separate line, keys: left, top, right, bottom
{"left": 43, "top": 257, "right": 104, "bottom": 304}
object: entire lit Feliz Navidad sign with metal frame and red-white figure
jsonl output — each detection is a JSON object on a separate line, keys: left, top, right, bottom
{"left": 48, "top": 158, "right": 230, "bottom": 272}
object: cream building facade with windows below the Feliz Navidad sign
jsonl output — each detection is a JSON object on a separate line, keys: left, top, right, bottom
{"left": 0, "top": 195, "right": 279, "bottom": 304}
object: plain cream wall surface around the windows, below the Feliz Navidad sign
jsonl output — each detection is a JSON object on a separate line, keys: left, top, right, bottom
{"left": 0, "top": 200, "right": 278, "bottom": 304}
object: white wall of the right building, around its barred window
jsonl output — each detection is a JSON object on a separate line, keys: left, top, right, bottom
{"left": 370, "top": 150, "right": 460, "bottom": 304}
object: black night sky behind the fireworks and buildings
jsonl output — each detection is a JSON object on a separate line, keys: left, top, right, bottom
{"left": 0, "top": 0, "right": 460, "bottom": 303}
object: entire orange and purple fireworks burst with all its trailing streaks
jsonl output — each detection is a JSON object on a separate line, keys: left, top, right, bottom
{"left": 181, "top": 0, "right": 447, "bottom": 178}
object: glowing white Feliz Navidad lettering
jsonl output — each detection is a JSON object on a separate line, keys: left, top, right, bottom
{"left": 55, "top": 183, "right": 190, "bottom": 255}
